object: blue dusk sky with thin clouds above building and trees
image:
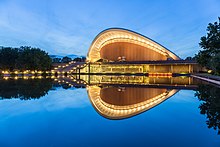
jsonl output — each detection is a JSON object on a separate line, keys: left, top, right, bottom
{"left": 0, "top": 0, "right": 220, "bottom": 58}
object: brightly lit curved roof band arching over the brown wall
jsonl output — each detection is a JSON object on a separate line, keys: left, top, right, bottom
{"left": 87, "top": 28, "right": 180, "bottom": 62}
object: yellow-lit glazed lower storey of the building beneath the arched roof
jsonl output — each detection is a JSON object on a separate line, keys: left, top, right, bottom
{"left": 77, "top": 63, "right": 196, "bottom": 74}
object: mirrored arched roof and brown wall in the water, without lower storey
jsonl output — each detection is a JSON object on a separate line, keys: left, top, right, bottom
{"left": 87, "top": 86, "right": 178, "bottom": 119}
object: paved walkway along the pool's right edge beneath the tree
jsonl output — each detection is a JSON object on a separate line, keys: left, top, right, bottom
{"left": 191, "top": 74, "right": 220, "bottom": 85}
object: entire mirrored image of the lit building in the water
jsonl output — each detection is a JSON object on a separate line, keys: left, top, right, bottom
{"left": 76, "top": 75, "right": 197, "bottom": 119}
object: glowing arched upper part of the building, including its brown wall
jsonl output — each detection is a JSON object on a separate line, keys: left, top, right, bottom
{"left": 87, "top": 28, "right": 180, "bottom": 62}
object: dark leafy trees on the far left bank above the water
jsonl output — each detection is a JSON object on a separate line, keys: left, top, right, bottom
{"left": 0, "top": 46, "right": 52, "bottom": 71}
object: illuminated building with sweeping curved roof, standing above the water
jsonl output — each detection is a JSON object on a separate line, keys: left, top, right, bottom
{"left": 80, "top": 28, "right": 198, "bottom": 74}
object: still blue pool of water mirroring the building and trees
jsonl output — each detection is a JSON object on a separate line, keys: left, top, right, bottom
{"left": 0, "top": 75, "right": 220, "bottom": 147}
